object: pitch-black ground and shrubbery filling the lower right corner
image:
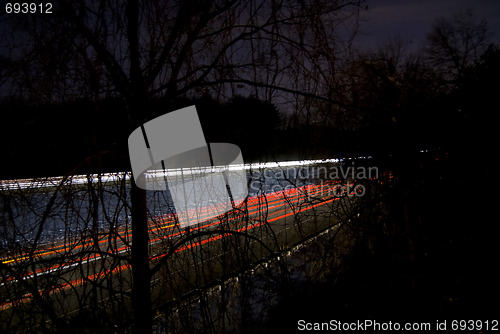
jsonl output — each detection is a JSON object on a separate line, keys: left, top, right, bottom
{"left": 268, "top": 152, "right": 500, "bottom": 333}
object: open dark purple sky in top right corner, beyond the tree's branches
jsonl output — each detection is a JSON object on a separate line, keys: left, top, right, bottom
{"left": 357, "top": 0, "right": 500, "bottom": 49}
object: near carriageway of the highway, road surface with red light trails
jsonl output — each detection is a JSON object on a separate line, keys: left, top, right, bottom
{"left": 0, "top": 180, "right": 356, "bottom": 328}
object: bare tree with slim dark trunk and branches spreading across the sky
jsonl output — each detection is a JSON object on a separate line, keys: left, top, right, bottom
{"left": 2, "top": 0, "right": 363, "bottom": 332}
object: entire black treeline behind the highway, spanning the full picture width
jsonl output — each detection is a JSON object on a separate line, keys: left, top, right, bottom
{"left": 1, "top": 41, "right": 500, "bottom": 178}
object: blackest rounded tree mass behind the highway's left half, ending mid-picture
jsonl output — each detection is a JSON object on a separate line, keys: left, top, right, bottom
{"left": 1, "top": 97, "right": 286, "bottom": 179}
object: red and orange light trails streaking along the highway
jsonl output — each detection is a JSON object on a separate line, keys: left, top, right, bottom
{"left": 0, "top": 182, "right": 354, "bottom": 311}
